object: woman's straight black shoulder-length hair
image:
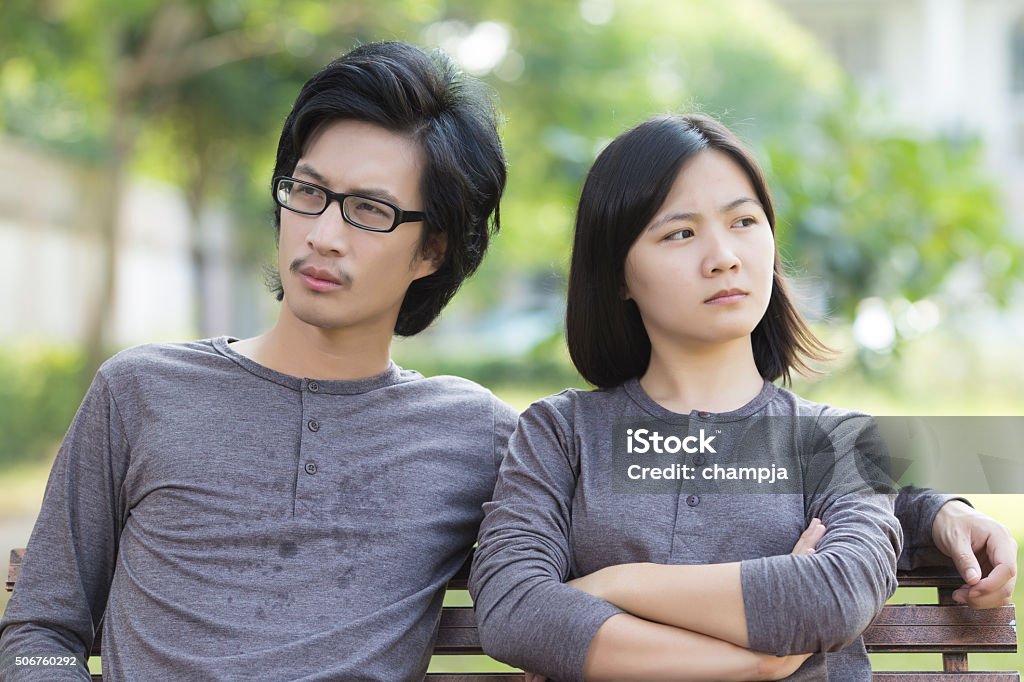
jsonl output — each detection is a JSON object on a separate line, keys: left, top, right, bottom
{"left": 565, "top": 115, "right": 828, "bottom": 388}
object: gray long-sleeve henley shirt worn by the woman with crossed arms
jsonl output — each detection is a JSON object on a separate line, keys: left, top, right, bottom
{"left": 470, "top": 380, "right": 909, "bottom": 682}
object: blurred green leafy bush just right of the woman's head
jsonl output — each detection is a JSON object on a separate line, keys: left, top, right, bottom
{"left": 766, "top": 94, "right": 1024, "bottom": 319}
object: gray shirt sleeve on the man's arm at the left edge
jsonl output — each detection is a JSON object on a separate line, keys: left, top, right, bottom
{"left": 0, "top": 370, "right": 128, "bottom": 682}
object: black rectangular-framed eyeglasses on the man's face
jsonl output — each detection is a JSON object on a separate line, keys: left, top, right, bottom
{"left": 273, "top": 175, "right": 427, "bottom": 232}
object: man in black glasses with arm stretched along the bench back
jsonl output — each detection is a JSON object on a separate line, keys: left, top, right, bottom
{"left": 0, "top": 38, "right": 1016, "bottom": 680}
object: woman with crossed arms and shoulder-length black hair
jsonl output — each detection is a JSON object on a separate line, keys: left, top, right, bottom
{"left": 470, "top": 116, "right": 901, "bottom": 682}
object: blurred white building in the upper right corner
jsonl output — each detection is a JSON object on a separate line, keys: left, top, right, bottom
{"left": 775, "top": 0, "right": 1024, "bottom": 235}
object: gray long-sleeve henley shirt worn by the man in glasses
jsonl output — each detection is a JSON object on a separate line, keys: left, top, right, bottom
{"left": 0, "top": 338, "right": 516, "bottom": 682}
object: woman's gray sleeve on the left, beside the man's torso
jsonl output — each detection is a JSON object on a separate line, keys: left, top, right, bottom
{"left": 469, "top": 402, "right": 623, "bottom": 681}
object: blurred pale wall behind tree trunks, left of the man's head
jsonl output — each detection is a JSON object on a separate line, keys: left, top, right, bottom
{"left": 0, "top": 137, "right": 254, "bottom": 347}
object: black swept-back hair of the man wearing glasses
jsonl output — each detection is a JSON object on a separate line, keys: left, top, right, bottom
{"left": 271, "top": 42, "right": 506, "bottom": 336}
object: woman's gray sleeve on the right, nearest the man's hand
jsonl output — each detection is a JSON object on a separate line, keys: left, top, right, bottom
{"left": 740, "top": 416, "right": 902, "bottom": 655}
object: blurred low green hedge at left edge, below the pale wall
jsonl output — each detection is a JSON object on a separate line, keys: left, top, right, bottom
{"left": 0, "top": 345, "right": 85, "bottom": 462}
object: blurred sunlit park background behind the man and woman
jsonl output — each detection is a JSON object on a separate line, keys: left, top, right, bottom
{"left": 0, "top": 0, "right": 1024, "bottom": 669}
